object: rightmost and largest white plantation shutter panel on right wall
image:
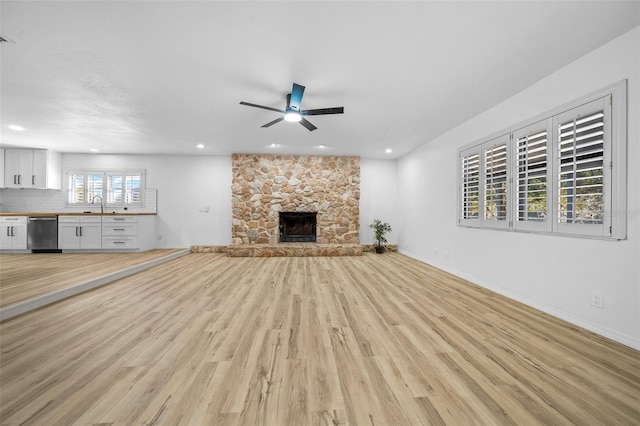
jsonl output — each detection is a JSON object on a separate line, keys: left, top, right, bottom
{"left": 554, "top": 97, "right": 610, "bottom": 235}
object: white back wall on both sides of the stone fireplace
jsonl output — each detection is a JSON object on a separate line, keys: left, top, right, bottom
{"left": 61, "top": 154, "right": 399, "bottom": 248}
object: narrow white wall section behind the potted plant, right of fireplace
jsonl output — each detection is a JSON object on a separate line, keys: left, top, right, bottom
{"left": 360, "top": 158, "right": 400, "bottom": 244}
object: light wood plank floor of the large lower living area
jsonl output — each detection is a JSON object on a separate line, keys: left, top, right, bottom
{"left": 0, "top": 253, "right": 640, "bottom": 425}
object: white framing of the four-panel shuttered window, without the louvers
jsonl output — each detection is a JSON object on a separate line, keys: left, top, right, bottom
{"left": 457, "top": 80, "right": 627, "bottom": 240}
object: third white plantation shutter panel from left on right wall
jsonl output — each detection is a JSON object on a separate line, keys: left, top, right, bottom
{"left": 513, "top": 120, "right": 551, "bottom": 231}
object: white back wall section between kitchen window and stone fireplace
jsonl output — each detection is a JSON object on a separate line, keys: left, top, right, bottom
{"left": 62, "top": 154, "right": 231, "bottom": 248}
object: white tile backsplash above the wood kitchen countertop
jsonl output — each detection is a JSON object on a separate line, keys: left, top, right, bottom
{"left": 0, "top": 189, "right": 158, "bottom": 213}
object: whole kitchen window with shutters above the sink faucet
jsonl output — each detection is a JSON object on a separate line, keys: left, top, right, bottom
{"left": 66, "top": 170, "right": 144, "bottom": 207}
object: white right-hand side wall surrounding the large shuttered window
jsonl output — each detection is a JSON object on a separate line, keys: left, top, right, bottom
{"left": 398, "top": 27, "right": 640, "bottom": 349}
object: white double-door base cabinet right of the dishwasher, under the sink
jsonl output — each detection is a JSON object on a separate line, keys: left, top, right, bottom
{"left": 58, "top": 216, "right": 102, "bottom": 250}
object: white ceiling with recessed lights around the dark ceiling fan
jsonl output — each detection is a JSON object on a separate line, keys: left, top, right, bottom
{"left": 0, "top": 0, "right": 640, "bottom": 158}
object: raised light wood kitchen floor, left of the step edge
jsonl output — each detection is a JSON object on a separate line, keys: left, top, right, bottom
{"left": 0, "top": 249, "right": 185, "bottom": 308}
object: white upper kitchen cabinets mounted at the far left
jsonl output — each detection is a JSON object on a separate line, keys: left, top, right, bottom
{"left": 3, "top": 148, "right": 62, "bottom": 189}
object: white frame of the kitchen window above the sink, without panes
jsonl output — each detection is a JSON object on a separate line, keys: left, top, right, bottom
{"left": 64, "top": 169, "right": 146, "bottom": 208}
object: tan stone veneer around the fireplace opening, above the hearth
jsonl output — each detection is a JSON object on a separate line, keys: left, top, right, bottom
{"left": 231, "top": 154, "right": 360, "bottom": 244}
